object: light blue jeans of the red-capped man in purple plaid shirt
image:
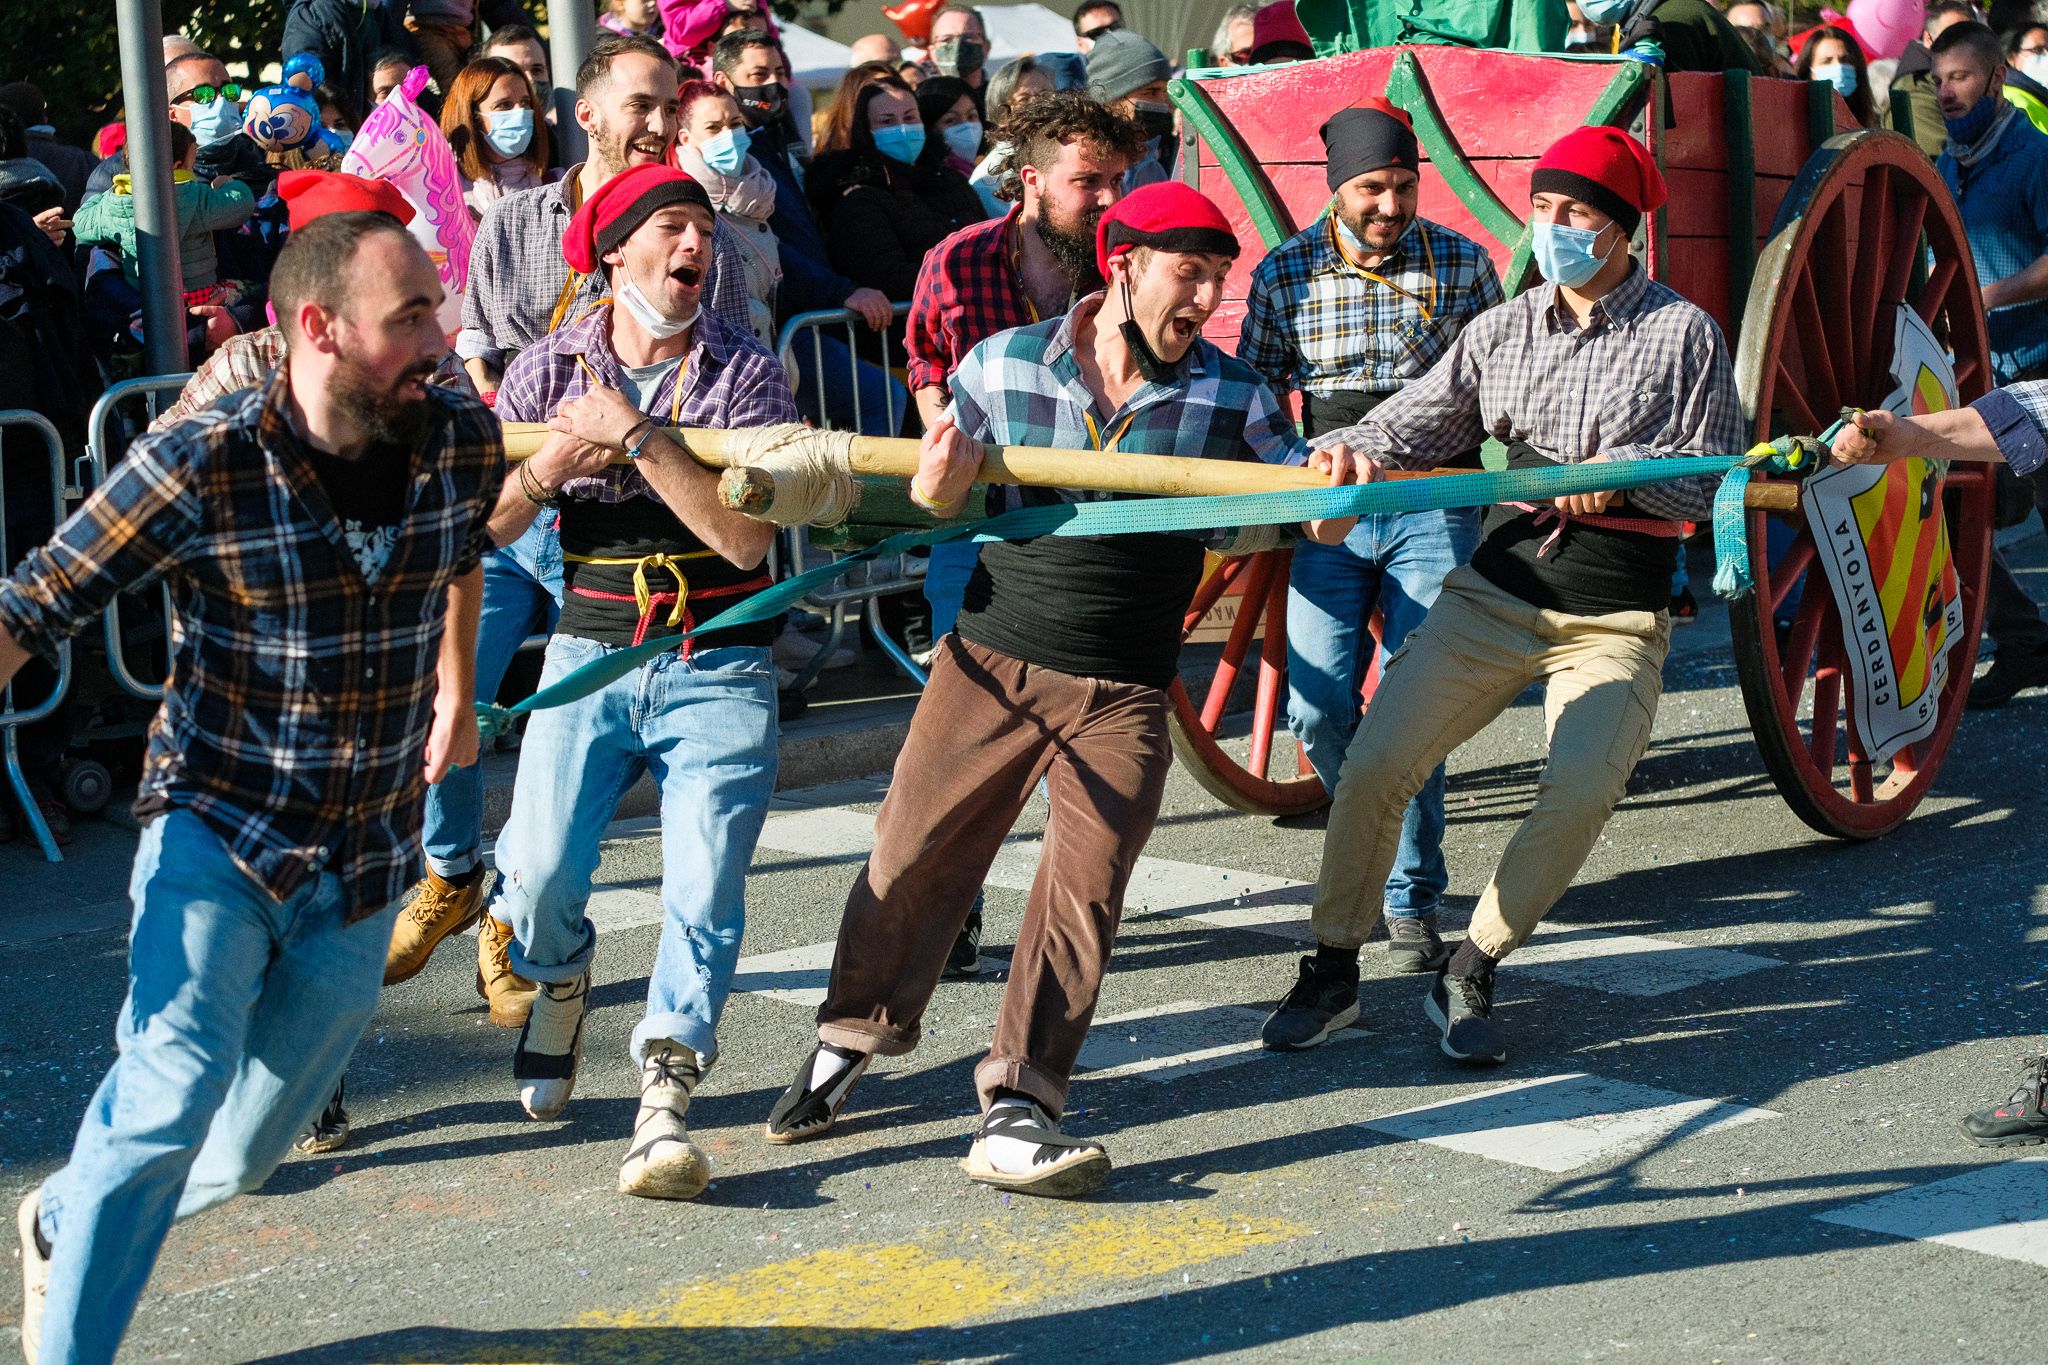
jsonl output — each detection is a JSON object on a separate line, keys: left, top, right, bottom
{"left": 492, "top": 634, "right": 776, "bottom": 1066}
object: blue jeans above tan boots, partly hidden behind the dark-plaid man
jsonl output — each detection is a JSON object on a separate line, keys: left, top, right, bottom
{"left": 424, "top": 508, "right": 561, "bottom": 878}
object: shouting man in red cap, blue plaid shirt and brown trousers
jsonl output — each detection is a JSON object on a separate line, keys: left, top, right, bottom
{"left": 766, "top": 180, "right": 1352, "bottom": 1197}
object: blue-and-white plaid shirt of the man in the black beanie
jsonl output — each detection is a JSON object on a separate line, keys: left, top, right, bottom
{"left": 1237, "top": 213, "right": 1505, "bottom": 397}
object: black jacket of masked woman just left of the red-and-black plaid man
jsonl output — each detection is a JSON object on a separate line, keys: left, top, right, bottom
{"left": 825, "top": 151, "right": 989, "bottom": 303}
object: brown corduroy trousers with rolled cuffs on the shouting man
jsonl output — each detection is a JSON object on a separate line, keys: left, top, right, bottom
{"left": 817, "top": 634, "right": 1174, "bottom": 1115}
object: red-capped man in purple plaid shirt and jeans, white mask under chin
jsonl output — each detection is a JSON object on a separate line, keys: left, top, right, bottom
{"left": 492, "top": 166, "right": 797, "bottom": 1199}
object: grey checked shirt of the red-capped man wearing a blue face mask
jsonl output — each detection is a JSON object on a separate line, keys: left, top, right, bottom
{"left": 1315, "top": 266, "right": 1751, "bottom": 520}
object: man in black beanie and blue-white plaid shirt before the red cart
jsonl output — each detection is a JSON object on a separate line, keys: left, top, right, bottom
{"left": 1237, "top": 98, "right": 1501, "bottom": 1052}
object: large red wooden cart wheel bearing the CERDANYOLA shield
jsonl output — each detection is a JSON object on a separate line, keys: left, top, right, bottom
{"left": 1731, "top": 131, "right": 1993, "bottom": 839}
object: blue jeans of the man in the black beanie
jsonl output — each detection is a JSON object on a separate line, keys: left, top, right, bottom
{"left": 1286, "top": 510, "right": 1479, "bottom": 919}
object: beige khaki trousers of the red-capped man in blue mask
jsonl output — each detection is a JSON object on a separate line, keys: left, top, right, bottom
{"left": 1313, "top": 567, "right": 1671, "bottom": 958}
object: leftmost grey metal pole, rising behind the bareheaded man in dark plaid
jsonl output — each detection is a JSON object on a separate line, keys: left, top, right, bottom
{"left": 115, "top": 0, "right": 188, "bottom": 375}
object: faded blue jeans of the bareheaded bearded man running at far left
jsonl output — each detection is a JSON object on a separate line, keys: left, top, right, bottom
{"left": 41, "top": 810, "right": 397, "bottom": 1365}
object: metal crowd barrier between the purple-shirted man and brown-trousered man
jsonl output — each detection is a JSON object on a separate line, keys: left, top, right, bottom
{"left": 774, "top": 313, "right": 926, "bottom": 692}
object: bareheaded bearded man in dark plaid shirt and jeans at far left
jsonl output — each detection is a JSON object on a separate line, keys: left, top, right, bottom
{"left": 0, "top": 213, "right": 504, "bottom": 1365}
